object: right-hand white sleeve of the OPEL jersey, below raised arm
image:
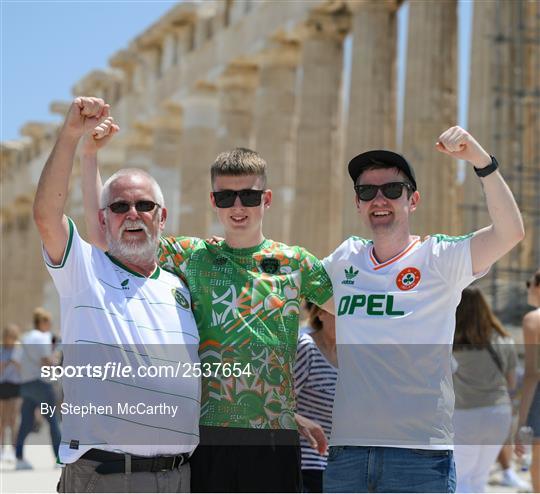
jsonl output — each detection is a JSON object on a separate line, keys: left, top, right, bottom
{"left": 430, "top": 233, "right": 485, "bottom": 290}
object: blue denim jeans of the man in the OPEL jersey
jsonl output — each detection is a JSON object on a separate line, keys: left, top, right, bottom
{"left": 323, "top": 446, "right": 456, "bottom": 492}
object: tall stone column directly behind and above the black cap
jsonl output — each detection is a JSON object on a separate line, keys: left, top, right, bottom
{"left": 342, "top": 0, "right": 398, "bottom": 238}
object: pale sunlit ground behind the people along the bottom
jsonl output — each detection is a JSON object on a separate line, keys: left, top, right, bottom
{"left": 0, "top": 425, "right": 527, "bottom": 494}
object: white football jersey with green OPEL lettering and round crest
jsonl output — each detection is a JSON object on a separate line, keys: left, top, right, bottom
{"left": 323, "top": 235, "right": 484, "bottom": 449}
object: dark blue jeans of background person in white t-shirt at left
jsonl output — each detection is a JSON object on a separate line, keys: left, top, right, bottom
{"left": 15, "top": 380, "right": 60, "bottom": 460}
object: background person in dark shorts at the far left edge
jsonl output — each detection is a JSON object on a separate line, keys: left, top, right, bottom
{"left": 0, "top": 324, "right": 21, "bottom": 460}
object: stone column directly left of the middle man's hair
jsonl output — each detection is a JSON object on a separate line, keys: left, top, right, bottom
{"left": 179, "top": 82, "right": 218, "bottom": 238}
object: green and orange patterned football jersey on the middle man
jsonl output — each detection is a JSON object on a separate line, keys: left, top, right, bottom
{"left": 159, "top": 237, "right": 332, "bottom": 429}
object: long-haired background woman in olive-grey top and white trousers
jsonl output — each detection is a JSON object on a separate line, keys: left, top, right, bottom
{"left": 454, "top": 287, "right": 517, "bottom": 492}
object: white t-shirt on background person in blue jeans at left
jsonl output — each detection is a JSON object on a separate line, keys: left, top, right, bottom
{"left": 13, "top": 329, "right": 53, "bottom": 383}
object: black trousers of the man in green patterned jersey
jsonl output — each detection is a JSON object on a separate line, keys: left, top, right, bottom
{"left": 190, "top": 426, "right": 302, "bottom": 492}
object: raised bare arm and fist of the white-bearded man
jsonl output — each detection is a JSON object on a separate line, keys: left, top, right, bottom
{"left": 33, "top": 97, "right": 115, "bottom": 264}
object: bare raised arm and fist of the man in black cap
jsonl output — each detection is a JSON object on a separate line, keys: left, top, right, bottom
{"left": 436, "top": 126, "right": 525, "bottom": 274}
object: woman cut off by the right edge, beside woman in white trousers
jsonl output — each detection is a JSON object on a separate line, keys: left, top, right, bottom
{"left": 516, "top": 269, "right": 540, "bottom": 492}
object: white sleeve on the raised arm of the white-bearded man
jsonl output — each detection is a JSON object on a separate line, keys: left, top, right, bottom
{"left": 42, "top": 218, "right": 95, "bottom": 297}
